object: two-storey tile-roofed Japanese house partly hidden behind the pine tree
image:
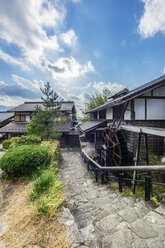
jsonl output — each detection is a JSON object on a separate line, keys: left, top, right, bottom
{"left": 0, "top": 101, "right": 79, "bottom": 146}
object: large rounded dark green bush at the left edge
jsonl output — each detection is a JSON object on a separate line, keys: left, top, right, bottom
{"left": 0, "top": 145, "right": 51, "bottom": 177}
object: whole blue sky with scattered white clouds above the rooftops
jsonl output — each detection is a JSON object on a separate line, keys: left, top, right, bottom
{"left": 0, "top": 0, "right": 165, "bottom": 115}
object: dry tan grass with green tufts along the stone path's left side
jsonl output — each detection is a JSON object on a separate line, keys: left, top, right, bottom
{"left": 0, "top": 142, "right": 69, "bottom": 248}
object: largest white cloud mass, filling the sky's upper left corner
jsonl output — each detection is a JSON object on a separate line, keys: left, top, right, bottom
{"left": 0, "top": 0, "right": 65, "bottom": 66}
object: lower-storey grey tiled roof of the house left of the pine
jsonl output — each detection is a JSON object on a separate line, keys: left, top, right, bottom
{"left": 0, "top": 122, "right": 26, "bottom": 133}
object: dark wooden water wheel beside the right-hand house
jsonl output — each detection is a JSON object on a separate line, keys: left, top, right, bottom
{"left": 102, "top": 127, "right": 122, "bottom": 166}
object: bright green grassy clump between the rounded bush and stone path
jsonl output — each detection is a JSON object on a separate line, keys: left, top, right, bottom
{"left": 30, "top": 170, "right": 55, "bottom": 199}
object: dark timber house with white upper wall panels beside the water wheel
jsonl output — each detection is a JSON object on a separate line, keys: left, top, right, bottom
{"left": 84, "top": 76, "right": 165, "bottom": 163}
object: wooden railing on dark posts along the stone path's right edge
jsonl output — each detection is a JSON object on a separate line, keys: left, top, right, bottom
{"left": 81, "top": 150, "right": 165, "bottom": 201}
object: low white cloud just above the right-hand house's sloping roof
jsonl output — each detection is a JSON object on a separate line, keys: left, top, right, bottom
{"left": 93, "top": 82, "right": 125, "bottom": 95}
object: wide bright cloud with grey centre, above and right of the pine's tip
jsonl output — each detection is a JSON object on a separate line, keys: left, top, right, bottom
{"left": 44, "top": 57, "right": 94, "bottom": 79}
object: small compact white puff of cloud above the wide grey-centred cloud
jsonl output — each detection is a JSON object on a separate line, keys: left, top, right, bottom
{"left": 59, "top": 29, "right": 78, "bottom": 47}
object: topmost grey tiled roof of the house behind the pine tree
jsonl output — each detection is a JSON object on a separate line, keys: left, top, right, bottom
{"left": 8, "top": 101, "right": 74, "bottom": 112}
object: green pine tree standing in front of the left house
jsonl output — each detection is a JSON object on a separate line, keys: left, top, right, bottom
{"left": 27, "top": 83, "right": 61, "bottom": 139}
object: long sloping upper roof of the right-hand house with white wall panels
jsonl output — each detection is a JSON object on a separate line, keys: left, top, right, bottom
{"left": 86, "top": 75, "right": 165, "bottom": 113}
